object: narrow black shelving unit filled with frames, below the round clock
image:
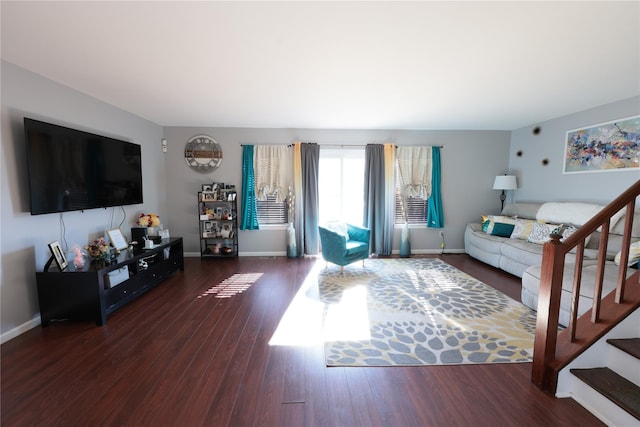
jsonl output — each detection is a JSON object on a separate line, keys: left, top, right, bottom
{"left": 198, "top": 188, "right": 238, "bottom": 259}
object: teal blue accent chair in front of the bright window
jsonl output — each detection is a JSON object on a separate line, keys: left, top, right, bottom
{"left": 318, "top": 223, "right": 371, "bottom": 273}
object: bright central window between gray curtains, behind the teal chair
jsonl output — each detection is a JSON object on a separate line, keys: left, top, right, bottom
{"left": 318, "top": 147, "right": 364, "bottom": 225}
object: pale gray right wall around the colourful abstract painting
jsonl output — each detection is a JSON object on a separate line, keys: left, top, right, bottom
{"left": 509, "top": 97, "right": 640, "bottom": 203}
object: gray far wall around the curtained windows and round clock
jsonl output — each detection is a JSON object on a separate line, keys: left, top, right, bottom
{"left": 164, "top": 127, "right": 510, "bottom": 255}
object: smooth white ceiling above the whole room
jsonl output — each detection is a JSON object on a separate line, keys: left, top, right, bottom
{"left": 1, "top": 1, "right": 640, "bottom": 130}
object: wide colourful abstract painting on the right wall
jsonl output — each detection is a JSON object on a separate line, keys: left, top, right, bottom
{"left": 563, "top": 116, "right": 640, "bottom": 174}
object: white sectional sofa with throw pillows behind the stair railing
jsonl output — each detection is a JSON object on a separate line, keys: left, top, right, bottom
{"left": 464, "top": 202, "right": 640, "bottom": 326}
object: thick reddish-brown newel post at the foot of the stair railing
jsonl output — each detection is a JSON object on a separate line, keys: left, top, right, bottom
{"left": 531, "top": 234, "right": 565, "bottom": 390}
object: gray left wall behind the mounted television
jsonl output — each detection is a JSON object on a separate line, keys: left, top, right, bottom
{"left": 0, "top": 61, "right": 169, "bottom": 341}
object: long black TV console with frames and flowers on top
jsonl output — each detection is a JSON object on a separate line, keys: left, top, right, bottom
{"left": 36, "top": 237, "right": 184, "bottom": 327}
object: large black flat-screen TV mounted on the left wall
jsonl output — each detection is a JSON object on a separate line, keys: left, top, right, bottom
{"left": 24, "top": 117, "right": 142, "bottom": 215}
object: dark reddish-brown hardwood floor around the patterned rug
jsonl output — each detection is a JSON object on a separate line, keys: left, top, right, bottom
{"left": 1, "top": 255, "right": 602, "bottom": 426}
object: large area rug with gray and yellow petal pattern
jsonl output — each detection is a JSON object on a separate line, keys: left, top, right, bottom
{"left": 318, "top": 258, "right": 536, "bottom": 366}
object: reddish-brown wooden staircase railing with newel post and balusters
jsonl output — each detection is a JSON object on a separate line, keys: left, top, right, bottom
{"left": 531, "top": 180, "right": 640, "bottom": 393}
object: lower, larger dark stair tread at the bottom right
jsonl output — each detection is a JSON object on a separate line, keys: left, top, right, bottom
{"left": 571, "top": 368, "right": 640, "bottom": 420}
